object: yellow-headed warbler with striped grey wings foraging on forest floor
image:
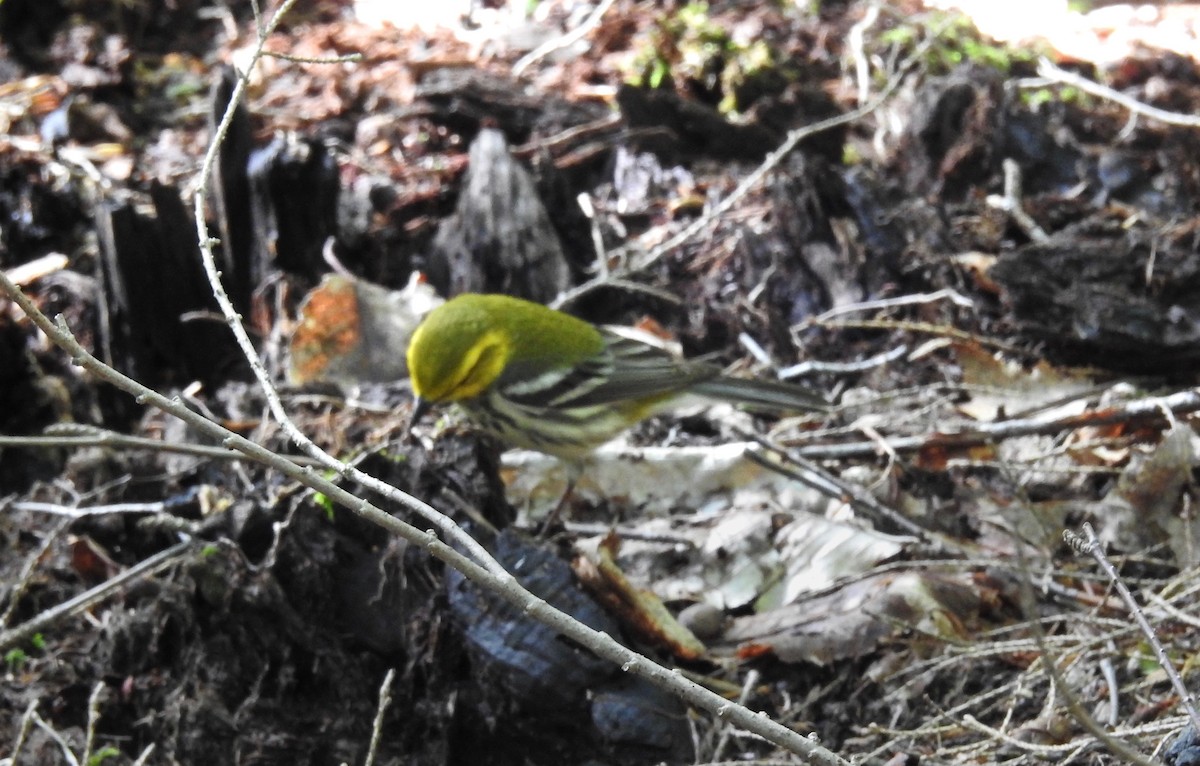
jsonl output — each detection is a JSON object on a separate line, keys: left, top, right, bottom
{"left": 408, "top": 293, "right": 829, "bottom": 462}
